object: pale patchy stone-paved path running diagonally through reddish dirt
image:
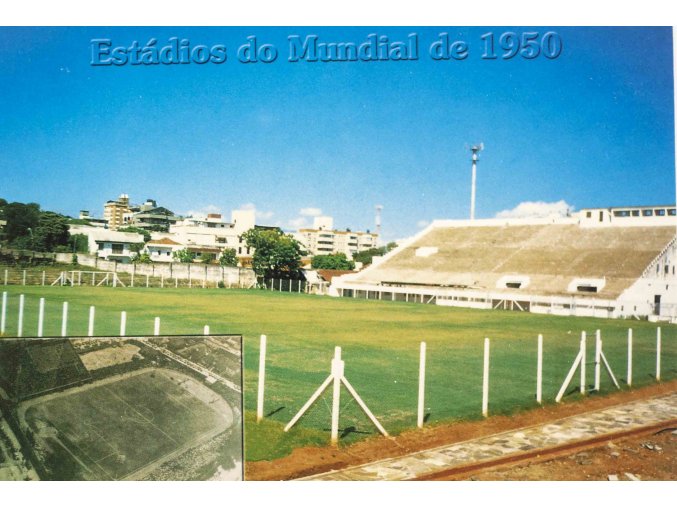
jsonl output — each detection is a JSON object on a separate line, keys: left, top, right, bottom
{"left": 301, "top": 393, "right": 677, "bottom": 481}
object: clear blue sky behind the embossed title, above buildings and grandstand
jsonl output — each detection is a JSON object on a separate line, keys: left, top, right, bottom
{"left": 0, "top": 27, "right": 675, "bottom": 240}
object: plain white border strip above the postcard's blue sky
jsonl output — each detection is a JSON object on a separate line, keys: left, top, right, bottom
{"left": 0, "top": 0, "right": 677, "bottom": 26}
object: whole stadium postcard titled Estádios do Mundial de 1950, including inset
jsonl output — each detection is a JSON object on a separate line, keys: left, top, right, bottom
{"left": 0, "top": 26, "right": 677, "bottom": 481}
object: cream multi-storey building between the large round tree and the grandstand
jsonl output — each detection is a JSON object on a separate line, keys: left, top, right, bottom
{"left": 295, "top": 216, "right": 378, "bottom": 259}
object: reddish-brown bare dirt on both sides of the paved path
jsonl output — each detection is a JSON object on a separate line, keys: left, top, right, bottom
{"left": 245, "top": 381, "right": 677, "bottom": 480}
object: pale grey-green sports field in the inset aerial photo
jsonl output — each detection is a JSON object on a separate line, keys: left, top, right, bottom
{"left": 19, "top": 370, "right": 233, "bottom": 480}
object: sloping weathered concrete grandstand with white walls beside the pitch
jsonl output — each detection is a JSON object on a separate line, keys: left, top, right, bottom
{"left": 330, "top": 206, "right": 677, "bottom": 321}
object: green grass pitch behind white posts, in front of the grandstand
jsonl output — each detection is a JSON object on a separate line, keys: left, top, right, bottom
{"left": 1, "top": 286, "right": 677, "bottom": 460}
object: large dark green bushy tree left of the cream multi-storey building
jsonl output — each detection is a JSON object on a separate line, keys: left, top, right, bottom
{"left": 242, "top": 229, "right": 304, "bottom": 280}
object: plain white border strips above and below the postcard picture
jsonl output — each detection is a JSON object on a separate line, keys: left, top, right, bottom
{"left": 0, "top": 0, "right": 677, "bottom": 507}
